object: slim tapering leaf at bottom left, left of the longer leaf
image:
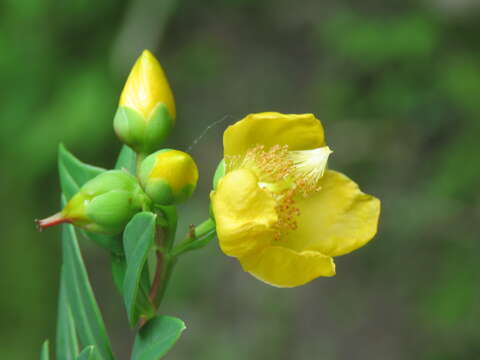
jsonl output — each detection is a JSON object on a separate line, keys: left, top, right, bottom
{"left": 56, "top": 267, "right": 78, "bottom": 360}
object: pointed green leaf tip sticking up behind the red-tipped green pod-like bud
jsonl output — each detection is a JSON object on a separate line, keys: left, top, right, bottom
{"left": 58, "top": 144, "right": 105, "bottom": 200}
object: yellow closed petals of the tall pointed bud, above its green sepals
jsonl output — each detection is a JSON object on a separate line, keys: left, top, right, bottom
{"left": 120, "top": 50, "right": 176, "bottom": 120}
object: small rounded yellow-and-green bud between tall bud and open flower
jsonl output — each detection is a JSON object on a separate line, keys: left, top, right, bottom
{"left": 139, "top": 149, "right": 198, "bottom": 205}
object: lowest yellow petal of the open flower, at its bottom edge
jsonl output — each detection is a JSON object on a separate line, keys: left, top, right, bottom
{"left": 239, "top": 246, "right": 335, "bottom": 287}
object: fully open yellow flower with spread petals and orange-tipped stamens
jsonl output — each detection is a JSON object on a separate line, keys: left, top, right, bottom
{"left": 211, "top": 112, "right": 380, "bottom": 287}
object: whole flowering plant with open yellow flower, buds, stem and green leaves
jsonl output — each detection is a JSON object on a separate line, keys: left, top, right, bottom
{"left": 38, "top": 51, "right": 380, "bottom": 360}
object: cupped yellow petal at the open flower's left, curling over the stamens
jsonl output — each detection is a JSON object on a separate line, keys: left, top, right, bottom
{"left": 211, "top": 169, "right": 278, "bottom": 257}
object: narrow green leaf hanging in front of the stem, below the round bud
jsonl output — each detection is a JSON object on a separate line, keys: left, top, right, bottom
{"left": 123, "top": 212, "right": 156, "bottom": 327}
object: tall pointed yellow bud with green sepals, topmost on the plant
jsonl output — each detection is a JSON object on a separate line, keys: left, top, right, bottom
{"left": 113, "top": 50, "right": 176, "bottom": 154}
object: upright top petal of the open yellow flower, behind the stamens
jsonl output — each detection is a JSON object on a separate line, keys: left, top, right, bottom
{"left": 223, "top": 112, "right": 325, "bottom": 156}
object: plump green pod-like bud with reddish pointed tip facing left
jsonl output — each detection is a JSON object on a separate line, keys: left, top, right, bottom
{"left": 38, "top": 170, "right": 149, "bottom": 235}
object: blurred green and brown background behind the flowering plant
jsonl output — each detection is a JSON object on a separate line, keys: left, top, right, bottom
{"left": 0, "top": 0, "right": 480, "bottom": 360}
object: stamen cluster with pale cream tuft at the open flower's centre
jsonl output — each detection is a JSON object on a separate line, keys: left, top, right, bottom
{"left": 225, "top": 145, "right": 332, "bottom": 240}
